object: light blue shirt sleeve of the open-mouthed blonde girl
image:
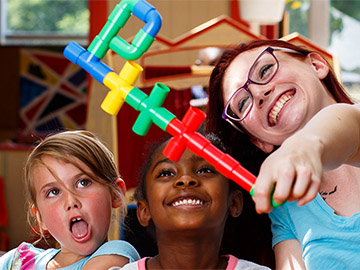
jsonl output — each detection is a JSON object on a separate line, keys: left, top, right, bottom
{"left": 89, "top": 240, "right": 140, "bottom": 263}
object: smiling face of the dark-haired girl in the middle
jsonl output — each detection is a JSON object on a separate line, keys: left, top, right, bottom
{"left": 138, "top": 144, "right": 242, "bottom": 234}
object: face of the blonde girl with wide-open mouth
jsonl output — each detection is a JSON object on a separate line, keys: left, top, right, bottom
{"left": 33, "top": 156, "right": 121, "bottom": 256}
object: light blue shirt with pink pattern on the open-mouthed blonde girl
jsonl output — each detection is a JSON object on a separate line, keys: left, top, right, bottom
{"left": 0, "top": 240, "right": 140, "bottom": 270}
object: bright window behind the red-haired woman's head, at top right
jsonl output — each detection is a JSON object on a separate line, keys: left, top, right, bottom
{"left": 286, "top": 0, "right": 360, "bottom": 100}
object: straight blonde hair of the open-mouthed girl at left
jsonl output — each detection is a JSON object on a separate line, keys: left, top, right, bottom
{"left": 25, "top": 131, "right": 126, "bottom": 240}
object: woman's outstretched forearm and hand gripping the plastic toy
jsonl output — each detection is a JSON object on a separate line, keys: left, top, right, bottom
{"left": 254, "top": 104, "right": 360, "bottom": 213}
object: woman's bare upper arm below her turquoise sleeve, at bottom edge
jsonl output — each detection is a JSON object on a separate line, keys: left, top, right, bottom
{"left": 274, "top": 239, "right": 305, "bottom": 270}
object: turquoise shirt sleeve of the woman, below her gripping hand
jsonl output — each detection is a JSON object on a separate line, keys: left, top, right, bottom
{"left": 269, "top": 203, "right": 297, "bottom": 248}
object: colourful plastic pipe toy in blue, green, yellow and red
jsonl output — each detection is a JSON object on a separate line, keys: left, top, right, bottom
{"left": 64, "top": 0, "right": 277, "bottom": 206}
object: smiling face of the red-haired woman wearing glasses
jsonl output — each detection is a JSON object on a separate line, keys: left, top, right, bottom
{"left": 223, "top": 46, "right": 335, "bottom": 152}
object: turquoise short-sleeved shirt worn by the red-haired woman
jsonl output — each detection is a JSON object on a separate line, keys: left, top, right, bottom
{"left": 269, "top": 194, "right": 360, "bottom": 270}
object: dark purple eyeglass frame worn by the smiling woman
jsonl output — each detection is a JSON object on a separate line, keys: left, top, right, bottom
{"left": 221, "top": 46, "right": 302, "bottom": 130}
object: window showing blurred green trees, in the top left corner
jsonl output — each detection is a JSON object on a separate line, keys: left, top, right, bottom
{"left": 0, "top": 0, "right": 89, "bottom": 45}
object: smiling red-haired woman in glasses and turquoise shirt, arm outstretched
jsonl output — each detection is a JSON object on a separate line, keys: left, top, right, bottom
{"left": 206, "top": 40, "right": 360, "bottom": 269}
